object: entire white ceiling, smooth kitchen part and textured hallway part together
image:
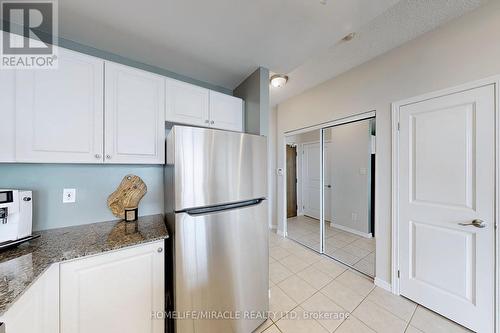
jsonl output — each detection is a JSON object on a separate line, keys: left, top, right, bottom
{"left": 59, "top": 0, "right": 487, "bottom": 104}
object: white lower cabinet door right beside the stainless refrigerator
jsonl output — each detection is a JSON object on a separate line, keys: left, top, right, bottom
{"left": 60, "top": 241, "right": 165, "bottom": 333}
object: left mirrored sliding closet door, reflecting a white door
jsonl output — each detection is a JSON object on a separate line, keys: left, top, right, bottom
{"left": 286, "top": 130, "right": 321, "bottom": 252}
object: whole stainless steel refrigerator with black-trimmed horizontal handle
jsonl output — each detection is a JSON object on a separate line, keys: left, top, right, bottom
{"left": 165, "top": 126, "right": 269, "bottom": 333}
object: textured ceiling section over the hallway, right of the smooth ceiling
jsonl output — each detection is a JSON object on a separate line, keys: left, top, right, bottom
{"left": 271, "top": 0, "right": 488, "bottom": 106}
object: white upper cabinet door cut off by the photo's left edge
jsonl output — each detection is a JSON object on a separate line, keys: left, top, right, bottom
{"left": 0, "top": 70, "right": 16, "bottom": 163}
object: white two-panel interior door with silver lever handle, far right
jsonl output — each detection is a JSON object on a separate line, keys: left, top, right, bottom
{"left": 398, "top": 85, "right": 495, "bottom": 332}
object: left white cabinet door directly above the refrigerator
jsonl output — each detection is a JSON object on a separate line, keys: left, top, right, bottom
{"left": 165, "top": 79, "right": 209, "bottom": 126}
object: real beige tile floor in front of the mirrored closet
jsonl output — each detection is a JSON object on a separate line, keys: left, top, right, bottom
{"left": 255, "top": 232, "right": 469, "bottom": 333}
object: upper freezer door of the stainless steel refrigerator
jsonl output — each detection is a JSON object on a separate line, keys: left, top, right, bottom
{"left": 167, "top": 126, "right": 267, "bottom": 212}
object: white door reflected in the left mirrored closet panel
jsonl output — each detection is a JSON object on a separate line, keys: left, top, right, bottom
{"left": 302, "top": 142, "right": 321, "bottom": 220}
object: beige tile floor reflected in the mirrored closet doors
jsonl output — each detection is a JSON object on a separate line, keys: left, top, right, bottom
{"left": 287, "top": 215, "right": 375, "bottom": 276}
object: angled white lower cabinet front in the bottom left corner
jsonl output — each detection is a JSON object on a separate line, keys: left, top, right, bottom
{"left": 0, "top": 264, "right": 59, "bottom": 333}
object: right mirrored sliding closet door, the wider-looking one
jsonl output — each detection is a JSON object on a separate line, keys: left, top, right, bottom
{"left": 323, "top": 119, "right": 375, "bottom": 276}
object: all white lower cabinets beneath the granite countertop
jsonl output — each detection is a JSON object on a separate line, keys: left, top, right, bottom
{"left": 0, "top": 241, "right": 165, "bottom": 333}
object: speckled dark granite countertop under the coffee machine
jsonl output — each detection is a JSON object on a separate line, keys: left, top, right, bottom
{"left": 0, "top": 214, "right": 170, "bottom": 321}
